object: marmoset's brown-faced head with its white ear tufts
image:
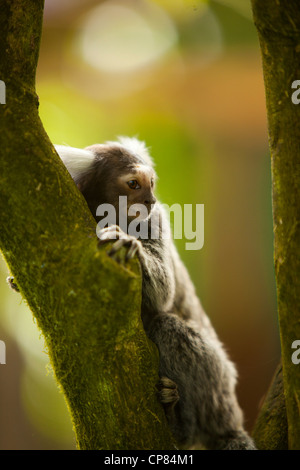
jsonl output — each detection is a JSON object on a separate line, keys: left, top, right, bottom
{"left": 55, "top": 137, "right": 156, "bottom": 223}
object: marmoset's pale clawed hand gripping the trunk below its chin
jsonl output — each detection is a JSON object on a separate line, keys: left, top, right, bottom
{"left": 98, "top": 225, "right": 142, "bottom": 261}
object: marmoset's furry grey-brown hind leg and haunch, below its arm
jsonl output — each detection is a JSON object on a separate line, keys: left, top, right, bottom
{"left": 148, "top": 314, "right": 255, "bottom": 449}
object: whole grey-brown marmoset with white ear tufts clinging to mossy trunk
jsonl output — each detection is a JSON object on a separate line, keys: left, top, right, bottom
{"left": 8, "top": 137, "right": 255, "bottom": 450}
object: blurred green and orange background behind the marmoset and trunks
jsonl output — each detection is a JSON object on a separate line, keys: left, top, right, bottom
{"left": 0, "top": 0, "right": 280, "bottom": 449}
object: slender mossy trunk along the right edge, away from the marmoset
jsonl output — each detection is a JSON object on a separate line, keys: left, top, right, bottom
{"left": 252, "top": 0, "right": 300, "bottom": 449}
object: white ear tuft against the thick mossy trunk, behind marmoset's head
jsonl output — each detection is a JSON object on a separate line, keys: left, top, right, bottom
{"left": 54, "top": 145, "right": 95, "bottom": 181}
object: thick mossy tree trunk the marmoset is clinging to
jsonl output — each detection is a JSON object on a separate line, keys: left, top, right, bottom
{"left": 0, "top": 0, "right": 174, "bottom": 450}
